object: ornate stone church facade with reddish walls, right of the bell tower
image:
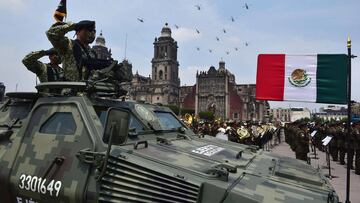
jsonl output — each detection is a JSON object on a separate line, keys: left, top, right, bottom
{"left": 180, "top": 61, "right": 269, "bottom": 121}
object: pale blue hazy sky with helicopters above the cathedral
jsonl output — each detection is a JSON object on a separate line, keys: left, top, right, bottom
{"left": 0, "top": 0, "right": 360, "bottom": 110}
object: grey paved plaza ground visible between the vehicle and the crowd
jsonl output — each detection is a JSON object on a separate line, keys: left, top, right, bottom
{"left": 271, "top": 133, "right": 360, "bottom": 203}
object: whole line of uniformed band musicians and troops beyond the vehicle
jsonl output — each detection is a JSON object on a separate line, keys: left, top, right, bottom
{"left": 183, "top": 114, "right": 360, "bottom": 175}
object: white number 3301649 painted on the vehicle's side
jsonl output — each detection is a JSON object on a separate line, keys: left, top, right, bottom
{"left": 19, "top": 174, "right": 62, "bottom": 197}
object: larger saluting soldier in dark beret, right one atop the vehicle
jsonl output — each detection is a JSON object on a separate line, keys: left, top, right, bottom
{"left": 46, "top": 20, "right": 111, "bottom": 81}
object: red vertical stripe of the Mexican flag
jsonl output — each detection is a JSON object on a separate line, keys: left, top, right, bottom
{"left": 256, "top": 54, "right": 285, "bottom": 101}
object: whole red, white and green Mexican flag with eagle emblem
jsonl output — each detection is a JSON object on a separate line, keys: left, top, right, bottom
{"left": 256, "top": 54, "right": 348, "bottom": 104}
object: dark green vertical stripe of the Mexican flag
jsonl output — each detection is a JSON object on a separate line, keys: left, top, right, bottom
{"left": 316, "top": 54, "right": 348, "bottom": 104}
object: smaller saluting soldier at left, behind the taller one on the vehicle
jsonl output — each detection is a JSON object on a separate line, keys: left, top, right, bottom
{"left": 22, "top": 48, "right": 64, "bottom": 82}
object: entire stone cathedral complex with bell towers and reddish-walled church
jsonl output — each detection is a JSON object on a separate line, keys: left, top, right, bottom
{"left": 93, "top": 24, "right": 269, "bottom": 121}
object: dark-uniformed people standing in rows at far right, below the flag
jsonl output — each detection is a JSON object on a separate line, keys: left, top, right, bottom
{"left": 285, "top": 122, "right": 360, "bottom": 175}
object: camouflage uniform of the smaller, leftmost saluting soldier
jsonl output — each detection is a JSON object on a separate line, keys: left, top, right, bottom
{"left": 22, "top": 51, "right": 64, "bottom": 82}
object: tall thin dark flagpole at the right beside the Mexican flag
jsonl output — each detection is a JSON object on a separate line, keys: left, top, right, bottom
{"left": 345, "top": 37, "right": 355, "bottom": 203}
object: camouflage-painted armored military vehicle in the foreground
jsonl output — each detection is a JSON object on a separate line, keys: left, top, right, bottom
{"left": 0, "top": 82, "right": 339, "bottom": 203}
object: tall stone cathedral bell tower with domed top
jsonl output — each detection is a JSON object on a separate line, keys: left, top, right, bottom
{"left": 151, "top": 23, "right": 180, "bottom": 105}
